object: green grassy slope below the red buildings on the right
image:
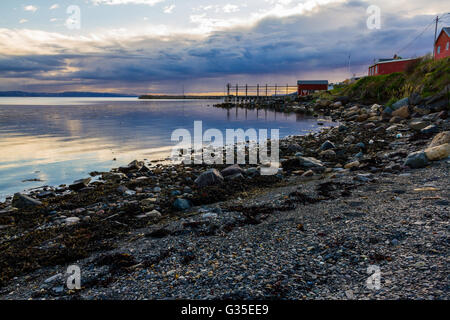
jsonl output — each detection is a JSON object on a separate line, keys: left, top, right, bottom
{"left": 320, "top": 56, "right": 450, "bottom": 105}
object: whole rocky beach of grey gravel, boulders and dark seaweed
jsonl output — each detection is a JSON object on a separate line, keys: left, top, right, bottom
{"left": 0, "top": 80, "right": 450, "bottom": 299}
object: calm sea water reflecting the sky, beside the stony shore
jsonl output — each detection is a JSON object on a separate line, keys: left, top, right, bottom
{"left": 0, "top": 98, "right": 332, "bottom": 199}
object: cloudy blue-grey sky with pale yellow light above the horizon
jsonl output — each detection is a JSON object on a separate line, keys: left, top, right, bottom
{"left": 0, "top": 0, "right": 450, "bottom": 94}
